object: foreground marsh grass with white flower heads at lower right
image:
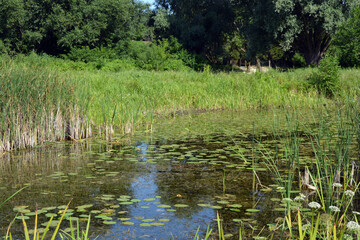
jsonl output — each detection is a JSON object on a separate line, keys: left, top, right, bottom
{"left": 243, "top": 99, "right": 360, "bottom": 239}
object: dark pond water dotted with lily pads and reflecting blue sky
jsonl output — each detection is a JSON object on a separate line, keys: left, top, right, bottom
{"left": 0, "top": 112, "right": 328, "bottom": 239}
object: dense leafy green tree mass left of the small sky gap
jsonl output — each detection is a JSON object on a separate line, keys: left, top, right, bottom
{"left": 0, "top": 0, "right": 151, "bottom": 55}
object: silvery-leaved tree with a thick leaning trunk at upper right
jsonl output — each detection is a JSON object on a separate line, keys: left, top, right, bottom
{"left": 244, "top": 0, "right": 349, "bottom": 65}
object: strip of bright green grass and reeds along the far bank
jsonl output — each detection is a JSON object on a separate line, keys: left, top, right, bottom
{"left": 0, "top": 55, "right": 360, "bottom": 150}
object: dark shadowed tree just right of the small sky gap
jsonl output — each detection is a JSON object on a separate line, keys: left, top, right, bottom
{"left": 157, "top": 0, "right": 235, "bottom": 63}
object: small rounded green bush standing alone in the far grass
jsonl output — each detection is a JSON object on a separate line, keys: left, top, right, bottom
{"left": 310, "top": 55, "right": 340, "bottom": 97}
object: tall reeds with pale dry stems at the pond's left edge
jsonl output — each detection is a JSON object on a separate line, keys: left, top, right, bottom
{"left": 0, "top": 57, "right": 91, "bottom": 152}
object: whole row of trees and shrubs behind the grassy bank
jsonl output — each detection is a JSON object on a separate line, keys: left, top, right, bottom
{"left": 0, "top": 0, "right": 360, "bottom": 70}
